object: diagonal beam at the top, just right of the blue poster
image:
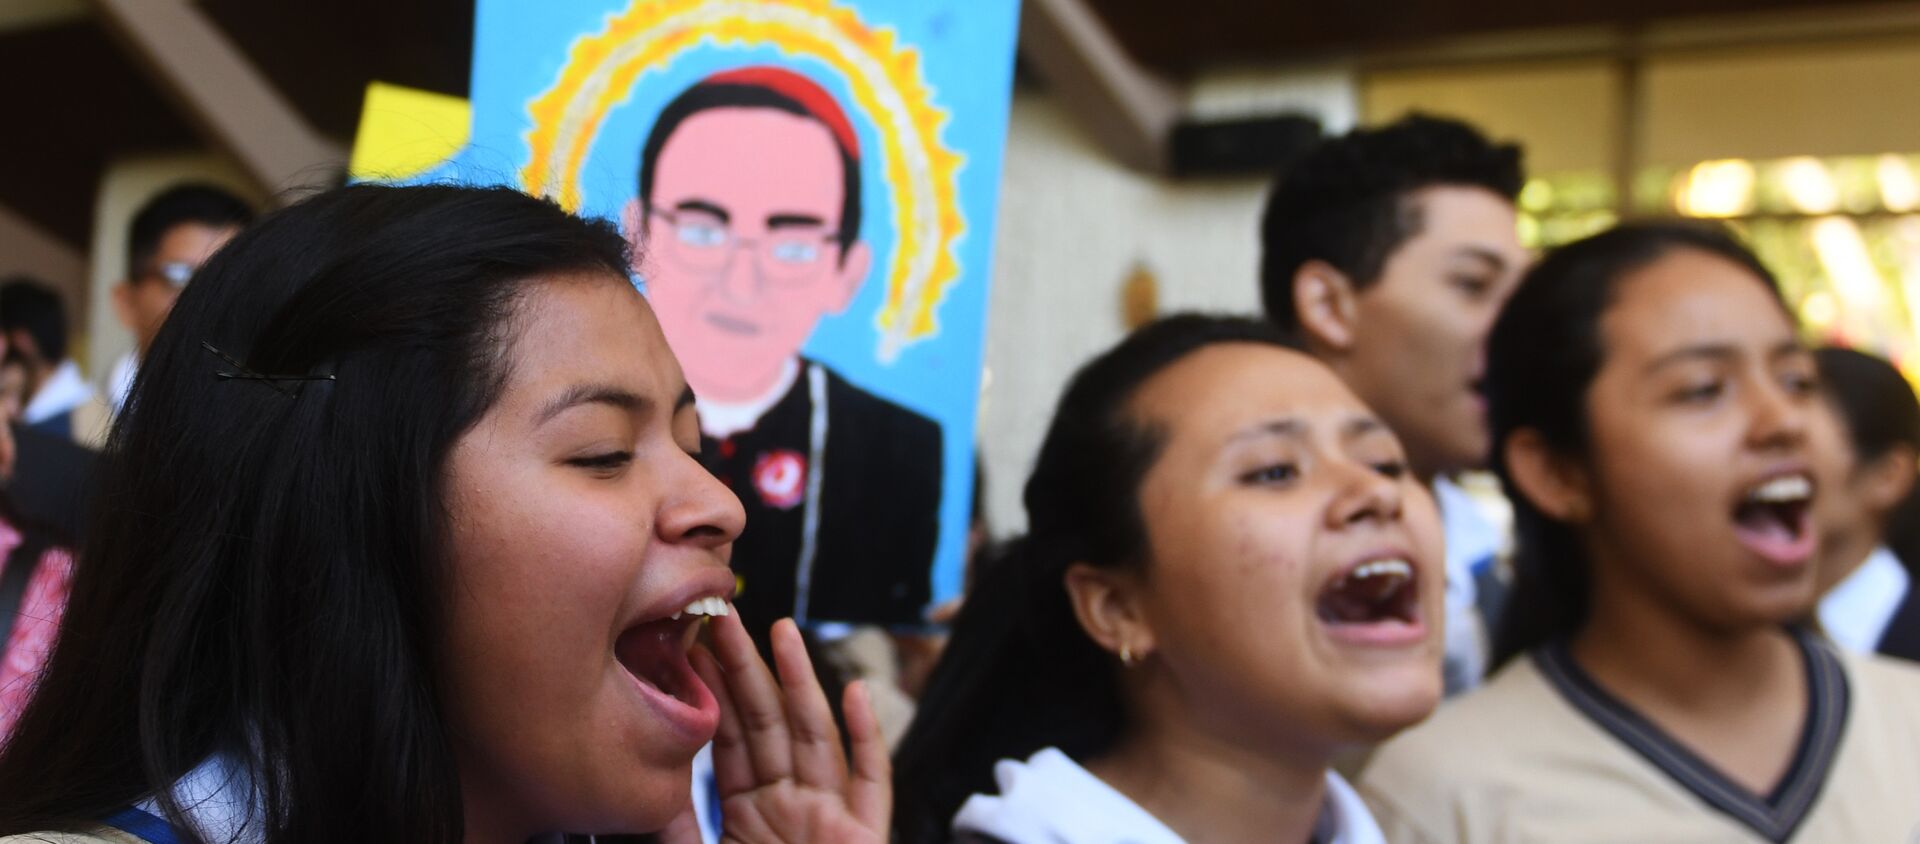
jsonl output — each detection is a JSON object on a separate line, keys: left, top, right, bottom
{"left": 1020, "top": 0, "right": 1185, "bottom": 173}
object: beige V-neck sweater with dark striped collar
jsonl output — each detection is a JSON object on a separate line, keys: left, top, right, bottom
{"left": 1359, "top": 639, "right": 1920, "bottom": 844}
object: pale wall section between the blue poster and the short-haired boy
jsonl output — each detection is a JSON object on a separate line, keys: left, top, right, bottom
{"left": 979, "top": 90, "right": 1265, "bottom": 535}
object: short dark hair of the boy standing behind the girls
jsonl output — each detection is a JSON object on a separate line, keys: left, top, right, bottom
{"left": 1260, "top": 113, "right": 1524, "bottom": 334}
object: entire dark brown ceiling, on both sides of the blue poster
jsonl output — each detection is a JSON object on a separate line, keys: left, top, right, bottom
{"left": 0, "top": 0, "right": 1896, "bottom": 247}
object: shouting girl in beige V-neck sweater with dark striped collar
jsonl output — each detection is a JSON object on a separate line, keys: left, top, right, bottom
{"left": 1361, "top": 224, "right": 1920, "bottom": 844}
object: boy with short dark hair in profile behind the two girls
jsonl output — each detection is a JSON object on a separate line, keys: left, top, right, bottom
{"left": 1260, "top": 115, "right": 1530, "bottom": 692}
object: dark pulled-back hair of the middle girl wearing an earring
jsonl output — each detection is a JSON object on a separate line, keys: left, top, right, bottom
{"left": 895, "top": 315, "right": 1286, "bottom": 842}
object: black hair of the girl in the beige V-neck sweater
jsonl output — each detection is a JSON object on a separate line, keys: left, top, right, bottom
{"left": 1484, "top": 223, "right": 1786, "bottom": 668}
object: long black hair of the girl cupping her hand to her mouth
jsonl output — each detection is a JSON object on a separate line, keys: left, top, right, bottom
{"left": 0, "top": 186, "right": 628, "bottom": 842}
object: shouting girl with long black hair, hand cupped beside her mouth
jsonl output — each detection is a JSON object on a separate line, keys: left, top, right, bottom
{"left": 0, "top": 186, "right": 887, "bottom": 844}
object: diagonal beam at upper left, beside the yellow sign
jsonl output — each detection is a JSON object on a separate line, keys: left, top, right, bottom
{"left": 88, "top": 0, "right": 346, "bottom": 196}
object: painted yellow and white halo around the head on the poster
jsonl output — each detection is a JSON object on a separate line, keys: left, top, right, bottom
{"left": 520, "top": 0, "right": 966, "bottom": 363}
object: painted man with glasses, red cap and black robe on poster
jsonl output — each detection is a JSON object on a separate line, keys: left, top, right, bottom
{"left": 624, "top": 67, "right": 941, "bottom": 629}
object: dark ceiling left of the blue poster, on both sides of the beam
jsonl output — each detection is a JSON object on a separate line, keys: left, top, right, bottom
{"left": 0, "top": 0, "right": 472, "bottom": 249}
